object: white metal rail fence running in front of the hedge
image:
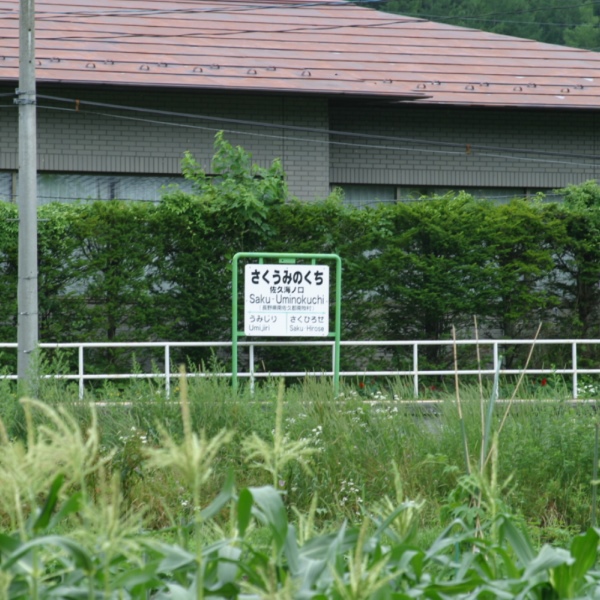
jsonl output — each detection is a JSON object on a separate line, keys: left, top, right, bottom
{"left": 0, "top": 339, "right": 600, "bottom": 399}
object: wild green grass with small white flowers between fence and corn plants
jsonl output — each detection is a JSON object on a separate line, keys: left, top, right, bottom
{"left": 0, "top": 370, "right": 596, "bottom": 540}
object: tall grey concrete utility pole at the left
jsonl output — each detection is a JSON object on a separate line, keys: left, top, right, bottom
{"left": 15, "top": 0, "right": 38, "bottom": 391}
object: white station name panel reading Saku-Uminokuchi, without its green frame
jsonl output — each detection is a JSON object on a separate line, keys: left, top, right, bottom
{"left": 244, "top": 264, "right": 329, "bottom": 337}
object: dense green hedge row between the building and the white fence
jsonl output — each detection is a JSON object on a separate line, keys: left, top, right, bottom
{"left": 0, "top": 139, "right": 600, "bottom": 376}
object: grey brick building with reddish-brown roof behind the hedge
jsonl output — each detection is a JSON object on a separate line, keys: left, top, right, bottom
{"left": 0, "top": 0, "right": 600, "bottom": 203}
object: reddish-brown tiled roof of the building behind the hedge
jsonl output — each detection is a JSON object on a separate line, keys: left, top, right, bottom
{"left": 0, "top": 0, "right": 600, "bottom": 108}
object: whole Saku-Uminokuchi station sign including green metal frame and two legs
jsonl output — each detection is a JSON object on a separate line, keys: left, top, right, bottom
{"left": 231, "top": 252, "right": 342, "bottom": 396}
